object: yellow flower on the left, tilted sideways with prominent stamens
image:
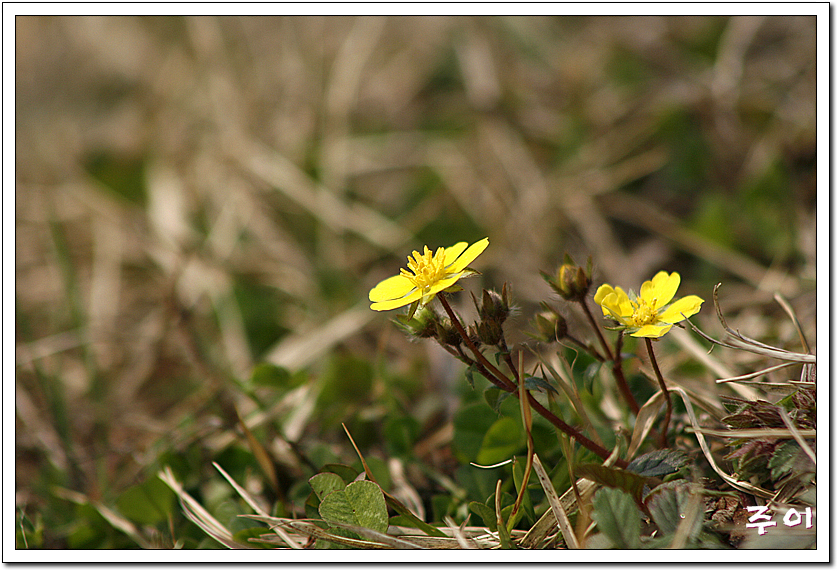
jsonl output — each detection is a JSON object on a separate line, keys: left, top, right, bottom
{"left": 370, "top": 238, "right": 489, "bottom": 311}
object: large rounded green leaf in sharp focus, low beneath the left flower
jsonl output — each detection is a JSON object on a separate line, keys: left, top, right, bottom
{"left": 320, "top": 480, "right": 389, "bottom": 533}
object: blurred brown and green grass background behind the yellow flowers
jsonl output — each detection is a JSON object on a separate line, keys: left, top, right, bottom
{"left": 15, "top": 17, "right": 816, "bottom": 547}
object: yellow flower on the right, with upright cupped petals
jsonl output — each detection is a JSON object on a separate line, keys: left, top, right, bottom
{"left": 594, "top": 272, "right": 704, "bottom": 338}
